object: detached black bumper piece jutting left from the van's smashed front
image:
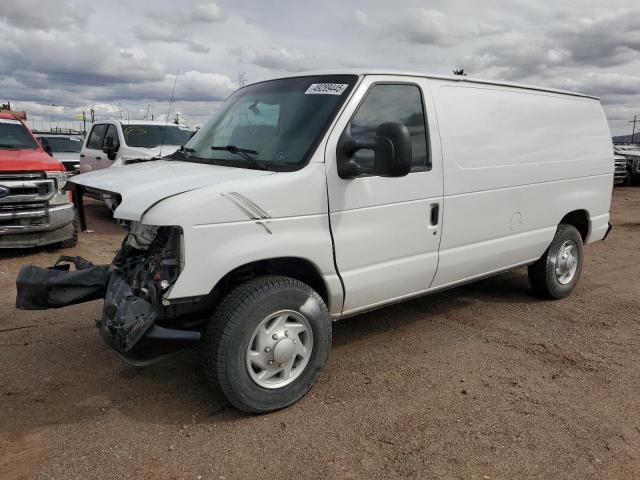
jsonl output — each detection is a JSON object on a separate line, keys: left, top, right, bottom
{"left": 16, "top": 255, "right": 112, "bottom": 310}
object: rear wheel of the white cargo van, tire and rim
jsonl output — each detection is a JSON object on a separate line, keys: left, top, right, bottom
{"left": 529, "top": 224, "right": 584, "bottom": 299}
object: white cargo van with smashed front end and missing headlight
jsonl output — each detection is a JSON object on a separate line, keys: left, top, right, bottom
{"left": 18, "top": 70, "right": 613, "bottom": 412}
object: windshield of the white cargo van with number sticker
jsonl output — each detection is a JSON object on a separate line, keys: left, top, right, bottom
{"left": 182, "top": 75, "right": 357, "bottom": 170}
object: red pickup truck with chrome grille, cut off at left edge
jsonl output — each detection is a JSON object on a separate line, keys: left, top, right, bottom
{"left": 0, "top": 113, "right": 78, "bottom": 248}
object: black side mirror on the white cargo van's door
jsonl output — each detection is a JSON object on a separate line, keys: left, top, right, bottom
{"left": 336, "top": 122, "right": 412, "bottom": 179}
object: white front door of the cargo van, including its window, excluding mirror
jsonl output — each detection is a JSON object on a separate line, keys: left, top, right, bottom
{"left": 325, "top": 76, "right": 443, "bottom": 314}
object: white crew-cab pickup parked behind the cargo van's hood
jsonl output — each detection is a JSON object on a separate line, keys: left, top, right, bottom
{"left": 80, "top": 120, "right": 193, "bottom": 173}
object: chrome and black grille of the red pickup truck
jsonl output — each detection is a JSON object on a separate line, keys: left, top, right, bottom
{"left": 0, "top": 172, "right": 56, "bottom": 233}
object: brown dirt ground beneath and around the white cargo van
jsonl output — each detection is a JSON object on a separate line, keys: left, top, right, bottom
{"left": 0, "top": 188, "right": 640, "bottom": 479}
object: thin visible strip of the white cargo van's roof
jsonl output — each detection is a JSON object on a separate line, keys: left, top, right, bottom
{"left": 254, "top": 68, "right": 600, "bottom": 100}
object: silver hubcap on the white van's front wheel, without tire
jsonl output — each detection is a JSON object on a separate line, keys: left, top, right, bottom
{"left": 247, "top": 310, "right": 313, "bottom": 389}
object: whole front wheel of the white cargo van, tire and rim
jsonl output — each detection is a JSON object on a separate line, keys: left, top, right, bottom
{"left": 202, "top": 276, "right": 331, "bottom": 413}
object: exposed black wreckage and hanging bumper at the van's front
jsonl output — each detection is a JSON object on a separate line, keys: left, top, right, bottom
{"left": 16, "top": 222, "right": 200, "bottom": 365}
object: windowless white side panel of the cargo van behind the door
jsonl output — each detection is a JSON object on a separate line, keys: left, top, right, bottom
{"left": 431, "top": 82, "right": 613, "bottom": 288}
